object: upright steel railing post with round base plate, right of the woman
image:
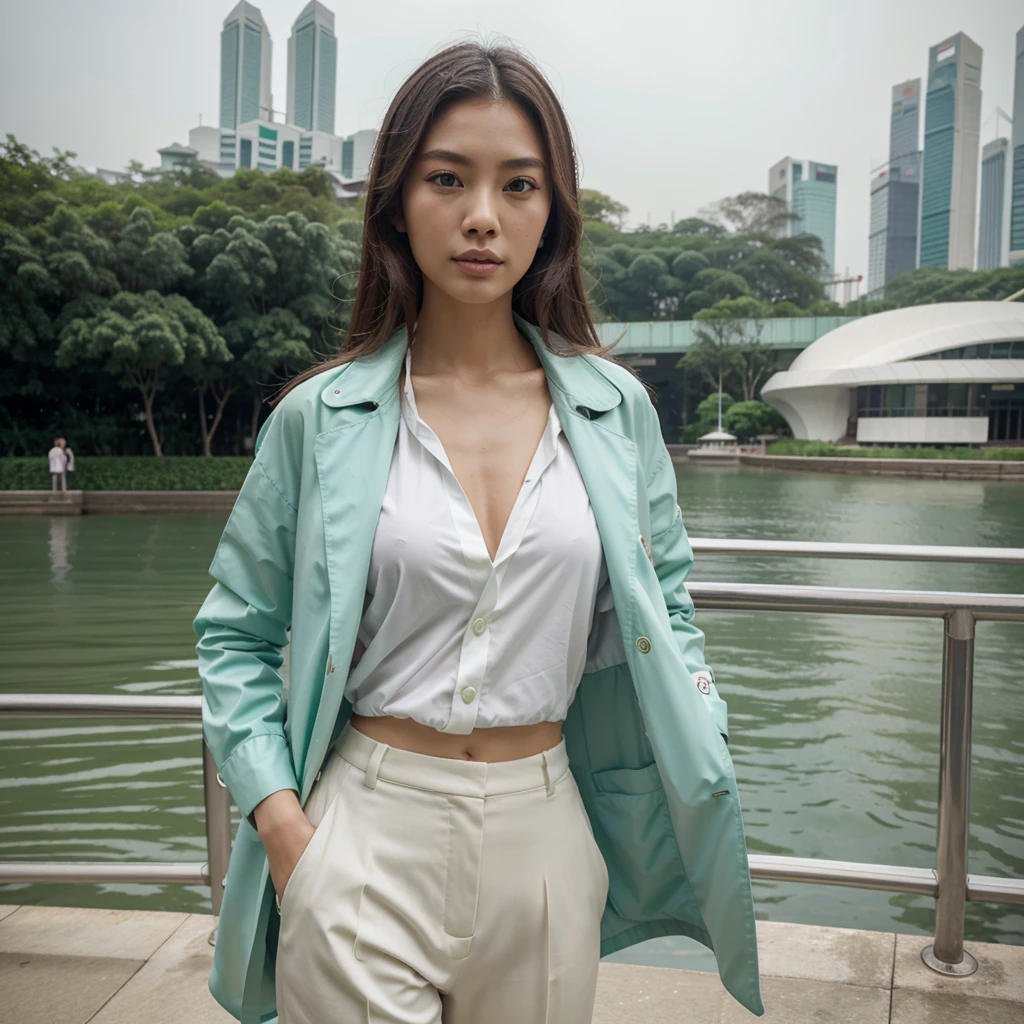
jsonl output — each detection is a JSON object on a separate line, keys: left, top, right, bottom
{"left": 921, "top": 608, "right": 978, "bottom": 977}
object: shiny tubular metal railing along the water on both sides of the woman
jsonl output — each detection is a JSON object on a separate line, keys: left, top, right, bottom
{"left": 0, "top": 538, "right": 1024, "bottom": 977}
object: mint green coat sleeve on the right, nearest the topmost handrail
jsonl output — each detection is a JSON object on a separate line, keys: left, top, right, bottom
{"left": 644, "top": 395, "right": 729, "bottom": 740}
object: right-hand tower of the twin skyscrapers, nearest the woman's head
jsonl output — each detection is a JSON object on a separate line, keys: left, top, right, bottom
{"left": 287, "top": 0, "right": 338, "bottom": 135}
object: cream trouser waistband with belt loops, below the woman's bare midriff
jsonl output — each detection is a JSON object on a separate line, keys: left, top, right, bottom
{"left": 334, "top": 722, "right": 569, "bottom": 797}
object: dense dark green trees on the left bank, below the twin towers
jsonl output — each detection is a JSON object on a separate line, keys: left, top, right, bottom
{"left": 0, "top": 136, "right": 361, "bottom": 455}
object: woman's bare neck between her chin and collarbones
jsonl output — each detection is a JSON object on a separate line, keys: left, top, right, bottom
{"left": 413, "top": 283, "right": 541, "bottom": 379}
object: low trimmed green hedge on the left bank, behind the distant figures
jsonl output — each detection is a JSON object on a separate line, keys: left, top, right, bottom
{"left": 0, "top": 456, "right": 252, "bottom": 490}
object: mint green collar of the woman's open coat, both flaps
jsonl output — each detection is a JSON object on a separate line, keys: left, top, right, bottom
{"left": 321, "top": 313, "right": 623, "bottom": 419}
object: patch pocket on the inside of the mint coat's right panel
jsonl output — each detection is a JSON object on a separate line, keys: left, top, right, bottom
{"left": 590, "top": 764, "right": 695, "bottom": 923}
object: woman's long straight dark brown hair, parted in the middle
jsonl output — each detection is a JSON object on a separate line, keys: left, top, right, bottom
{"left": 270, "top": 42, "right": 611, "bottom": 404}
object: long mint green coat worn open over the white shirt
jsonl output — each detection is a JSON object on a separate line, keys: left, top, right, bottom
{"left": 195, "top": 317, "right": 764, "bottom": 1024}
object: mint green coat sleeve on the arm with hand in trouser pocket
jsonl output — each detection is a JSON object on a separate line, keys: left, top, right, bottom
{"left": 193, "top": 409, "right": 299, "bottom": 821}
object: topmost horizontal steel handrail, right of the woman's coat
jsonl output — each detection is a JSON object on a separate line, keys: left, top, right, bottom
{"left": 690, "top": 537, "right": 1024, "bottom": 565}
